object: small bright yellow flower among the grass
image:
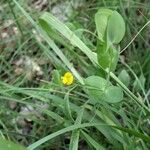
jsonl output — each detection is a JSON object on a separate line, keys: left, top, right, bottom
{"left": 61, "top": 72, "right": 74, "bottom": 85}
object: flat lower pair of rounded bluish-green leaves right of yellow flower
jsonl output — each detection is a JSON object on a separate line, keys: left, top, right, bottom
{"left": 85, "top": 76, "right": 123, "bottom": 103}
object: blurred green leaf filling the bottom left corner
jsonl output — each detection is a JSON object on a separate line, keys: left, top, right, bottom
{"left": 0, "top": 139, "right": 26, "bottom": 150}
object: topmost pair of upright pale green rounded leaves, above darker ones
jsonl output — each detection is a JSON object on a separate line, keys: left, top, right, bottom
{"left": 95, "top": 9, "right": 125, "bottom": 44}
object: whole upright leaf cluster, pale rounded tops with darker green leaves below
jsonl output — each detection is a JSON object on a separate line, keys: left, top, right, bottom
{"left": 95, "top": 9, "right": 125, "bottom": 71}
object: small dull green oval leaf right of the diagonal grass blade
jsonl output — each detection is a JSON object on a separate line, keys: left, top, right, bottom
{"left": 118, "top": 69, "right": 131, "bottom": 87}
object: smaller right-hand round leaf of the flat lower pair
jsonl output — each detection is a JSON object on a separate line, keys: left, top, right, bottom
{"left": 103, "top": 86, "right": 123, "bottom": 103}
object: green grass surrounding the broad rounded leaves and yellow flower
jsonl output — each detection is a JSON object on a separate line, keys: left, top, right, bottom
{"left": 0, "top": 0, "right": 150, "bottom": 150}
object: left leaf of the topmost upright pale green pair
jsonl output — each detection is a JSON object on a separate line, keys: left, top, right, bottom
{"left": 95, "top": 9, "right": 113, "bottom": 42}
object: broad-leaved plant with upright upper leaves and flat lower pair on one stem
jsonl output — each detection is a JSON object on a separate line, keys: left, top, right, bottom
{"left": 85, "top": 9, "right": 125, "bottom": 103}
